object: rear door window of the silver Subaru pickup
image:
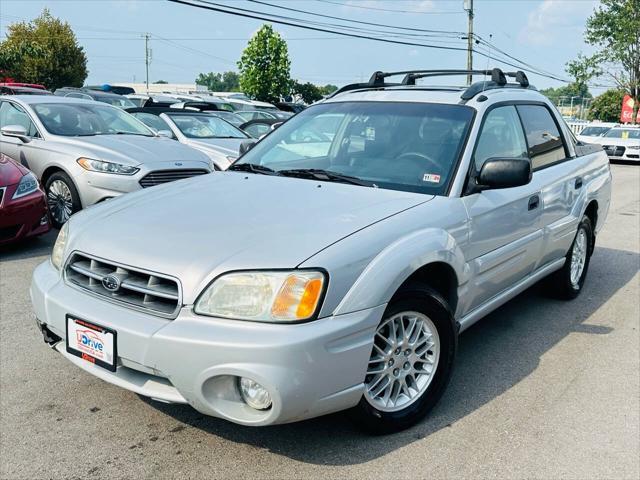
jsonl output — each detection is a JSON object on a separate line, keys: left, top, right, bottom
{"left": 517, "top": 105, "right": 566, "bottom": 170}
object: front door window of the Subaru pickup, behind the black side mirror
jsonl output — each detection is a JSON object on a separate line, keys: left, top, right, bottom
{"left": 474, "top": 105, "right": 527, "bottom": 172}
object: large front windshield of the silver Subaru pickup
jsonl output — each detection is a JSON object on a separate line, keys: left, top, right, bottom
{"left": 232, "top": 102, "right": 473, "bottom": 195}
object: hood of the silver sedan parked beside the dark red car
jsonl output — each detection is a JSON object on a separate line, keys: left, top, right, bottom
{"left": 55, "top": 135, "right": 209, "bottom": 166}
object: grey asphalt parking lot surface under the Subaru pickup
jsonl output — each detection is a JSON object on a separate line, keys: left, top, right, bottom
{"left": 0, "top": 165, "right": 640, "bottom": 479}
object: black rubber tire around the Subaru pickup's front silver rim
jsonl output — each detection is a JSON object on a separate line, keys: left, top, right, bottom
{"left": 352, "top": 283, "right": 458, "bottom": 434}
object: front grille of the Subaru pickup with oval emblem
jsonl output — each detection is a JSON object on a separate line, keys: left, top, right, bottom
{"left": 65, "top": 253, "right": 182, "bottom": 317}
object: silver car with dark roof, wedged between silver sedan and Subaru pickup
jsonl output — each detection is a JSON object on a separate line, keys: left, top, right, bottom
{"left": 127, "top": 108, "right": 254, "bottom": 170}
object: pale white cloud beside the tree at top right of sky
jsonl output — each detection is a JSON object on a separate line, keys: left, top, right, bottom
{"left": 518, "top": 0, "right": 598, "bottom": 46}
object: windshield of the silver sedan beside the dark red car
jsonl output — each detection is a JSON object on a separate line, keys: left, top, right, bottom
{"left": 33, "top": 102, "right": 153, "bottom": 137}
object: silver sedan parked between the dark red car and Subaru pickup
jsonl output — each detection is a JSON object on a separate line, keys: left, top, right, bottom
{"left": 0, "top": 95, "right": 212, "bottom": 227}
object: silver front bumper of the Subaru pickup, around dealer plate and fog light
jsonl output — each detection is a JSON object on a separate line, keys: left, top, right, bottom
{"left": 31, "top": 261, "right": 385, "bottom": 426}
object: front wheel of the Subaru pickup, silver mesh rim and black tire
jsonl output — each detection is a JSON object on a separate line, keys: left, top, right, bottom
{"left": 355, "top": 284, "right": 457, "bottom": 434}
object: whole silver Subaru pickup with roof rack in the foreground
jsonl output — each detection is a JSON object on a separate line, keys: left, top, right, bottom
{"left": 31, "top": 70, "right": 611, "bottom": 432}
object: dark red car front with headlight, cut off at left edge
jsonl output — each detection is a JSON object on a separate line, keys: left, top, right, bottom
{"left": 0, "top": 153, "right": 50, "bottom": 245}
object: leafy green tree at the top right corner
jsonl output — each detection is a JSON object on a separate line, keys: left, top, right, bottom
{"left": 570, "top": 0, "right": 640, "bottom": 121}
